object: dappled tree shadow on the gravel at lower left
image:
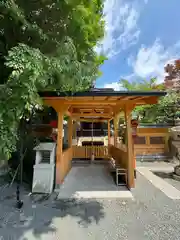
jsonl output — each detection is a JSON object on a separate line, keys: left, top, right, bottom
{"left": 0, "top": 183, "right": 104, "bottom": 240}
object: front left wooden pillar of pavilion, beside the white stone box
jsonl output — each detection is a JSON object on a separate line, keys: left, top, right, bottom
{"left": 56, "top": 111, "right": 64, "bottom": 184}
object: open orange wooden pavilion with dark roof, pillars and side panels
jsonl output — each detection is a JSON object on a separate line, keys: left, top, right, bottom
{"left": 39, "top": 89, "right": 166, "bottom": 189}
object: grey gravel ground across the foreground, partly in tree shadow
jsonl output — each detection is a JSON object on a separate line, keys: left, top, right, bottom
{"left": 0, "top": 174, "right": 180, "bottom": 240}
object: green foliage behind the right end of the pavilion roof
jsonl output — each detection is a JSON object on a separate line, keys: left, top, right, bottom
{"left": 120, "top": 78, "right": 179, "bottom": 123}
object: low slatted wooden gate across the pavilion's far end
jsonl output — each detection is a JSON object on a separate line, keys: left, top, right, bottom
{"left": 73, "top": 146, "right": 108, "bottom": 159}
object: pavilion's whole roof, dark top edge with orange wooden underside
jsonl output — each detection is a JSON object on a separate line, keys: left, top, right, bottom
{"left": 39, "top": 89, "right": 166, "bottom": 121}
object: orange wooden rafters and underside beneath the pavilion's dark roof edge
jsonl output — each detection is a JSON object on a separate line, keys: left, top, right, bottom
{"left": 44, "top": 96, "right": 158, "bottom": 118}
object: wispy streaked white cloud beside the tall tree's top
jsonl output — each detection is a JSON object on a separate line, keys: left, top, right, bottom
{"left": 96, "top": 0, "right": 140, "bottom": 58}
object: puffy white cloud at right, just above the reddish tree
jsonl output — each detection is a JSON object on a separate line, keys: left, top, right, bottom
{"left": 128, "top": 40, "right": 180, "bottom": 82}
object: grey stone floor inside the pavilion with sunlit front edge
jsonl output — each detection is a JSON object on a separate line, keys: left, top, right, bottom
{"left": 58, "top": 164, "right": 133, "bottom": 199}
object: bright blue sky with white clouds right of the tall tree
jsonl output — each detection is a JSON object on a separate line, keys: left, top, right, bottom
{"left": 96, "top": 0, "right": 180, "bottom": 90}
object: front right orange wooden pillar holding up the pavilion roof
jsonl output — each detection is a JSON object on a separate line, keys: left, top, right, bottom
{"left": 125, "top": 106, "right": 134, "bottom": 189}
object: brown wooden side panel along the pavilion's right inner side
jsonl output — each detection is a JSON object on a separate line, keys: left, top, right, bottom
{"left": 108, "top": 145, "right": 128, "bottom": 170}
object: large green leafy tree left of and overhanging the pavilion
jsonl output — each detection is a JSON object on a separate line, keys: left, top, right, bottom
{"left": 0, "top": 0, "right": 104, "bottom": 159}
